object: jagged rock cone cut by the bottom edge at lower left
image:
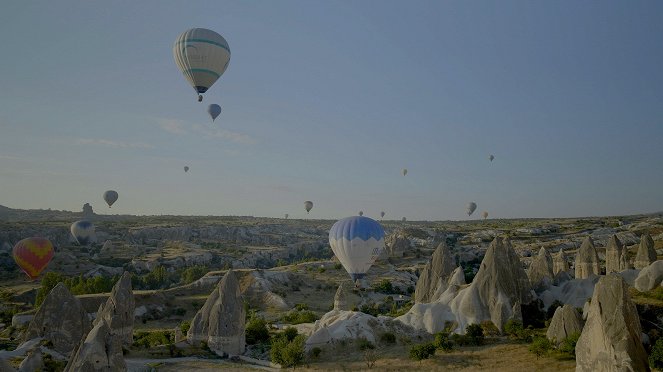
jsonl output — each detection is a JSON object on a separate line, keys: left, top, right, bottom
{"left": 65, "top": 319, "right": 127, "bottom": 372}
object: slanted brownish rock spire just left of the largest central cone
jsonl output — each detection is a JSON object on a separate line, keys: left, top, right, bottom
{"left": 414, "top": 243, "right": 456, "bottom": 303}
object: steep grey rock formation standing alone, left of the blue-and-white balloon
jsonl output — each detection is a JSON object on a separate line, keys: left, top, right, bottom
{"left": 187, "top": 270, "right": 246, "bottom": 355}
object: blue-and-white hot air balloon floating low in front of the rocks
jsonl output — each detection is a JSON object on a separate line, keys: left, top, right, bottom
{"left": 329, "top": 216, "right": 384, "bottom": 282}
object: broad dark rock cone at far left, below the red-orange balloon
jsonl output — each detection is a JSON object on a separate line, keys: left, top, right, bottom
{"left": 24, "top": 283, "right": 92, "bottom": 355}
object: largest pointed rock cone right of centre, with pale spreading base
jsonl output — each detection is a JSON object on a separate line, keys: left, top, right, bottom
{"left": 451, "top": 237, "right": 534, "bottom": 330}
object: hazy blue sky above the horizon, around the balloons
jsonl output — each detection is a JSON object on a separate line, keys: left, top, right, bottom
{"left": 0, "top": 0, "right": 663, "bottom": 220}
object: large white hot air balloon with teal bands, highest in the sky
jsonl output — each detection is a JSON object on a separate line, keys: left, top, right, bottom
{"left": 173, "top": 28, "right": 230, "bottom": 102}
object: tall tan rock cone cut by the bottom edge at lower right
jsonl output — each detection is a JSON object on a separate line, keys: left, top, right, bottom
{"left": 576, "top": 274, "right": 649, "bottom": 372}
